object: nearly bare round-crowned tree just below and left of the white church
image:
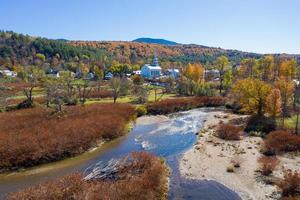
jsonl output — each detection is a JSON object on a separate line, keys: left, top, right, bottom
{"left": 109, "top": 77, "right": 130, "bottom": 103}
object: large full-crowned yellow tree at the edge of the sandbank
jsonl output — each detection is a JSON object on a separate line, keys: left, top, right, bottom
{"left": 232, "top": 78, "right": 271, "bottom": 116}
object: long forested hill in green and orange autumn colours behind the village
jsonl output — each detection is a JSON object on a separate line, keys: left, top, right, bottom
{"left": 0, "top": 31, "right": 298, "bottom": 68}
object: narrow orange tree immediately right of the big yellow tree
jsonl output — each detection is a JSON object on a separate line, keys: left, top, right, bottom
{"left": 266, "top": 88, "right": 282, "bottom": 119}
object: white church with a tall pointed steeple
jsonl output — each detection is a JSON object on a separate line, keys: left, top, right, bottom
{"left": 141, "top": 55, "right": 161, "bottom": 79}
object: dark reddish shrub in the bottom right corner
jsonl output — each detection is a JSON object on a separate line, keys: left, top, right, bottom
{"left": 278, "top": 171, "right": 300, "bottom": 199}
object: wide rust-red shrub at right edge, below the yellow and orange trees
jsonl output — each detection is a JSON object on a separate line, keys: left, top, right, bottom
{"left": 265, "top": 131, "right": 300, "bottom": 153}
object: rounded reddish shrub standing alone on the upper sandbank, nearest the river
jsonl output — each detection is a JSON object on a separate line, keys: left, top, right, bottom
{"left": 216, "top": 124, "right": 241, "bottom": 140}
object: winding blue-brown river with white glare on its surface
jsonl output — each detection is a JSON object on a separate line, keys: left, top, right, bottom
{"left": 0, "top": 108, "right": 240, "bottom": 200}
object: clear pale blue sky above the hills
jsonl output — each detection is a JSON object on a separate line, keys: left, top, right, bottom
{"left": 0, "top": 0, "right": 300, "bottom": 54}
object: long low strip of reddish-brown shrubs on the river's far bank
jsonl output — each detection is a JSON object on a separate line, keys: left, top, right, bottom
{"left": 147, "top": 97, "right": 225, "bottom": 115}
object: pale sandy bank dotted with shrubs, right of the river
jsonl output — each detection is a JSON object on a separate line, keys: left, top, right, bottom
{"left": 179, "top": 111, "right": 300, "bottom": 200}
